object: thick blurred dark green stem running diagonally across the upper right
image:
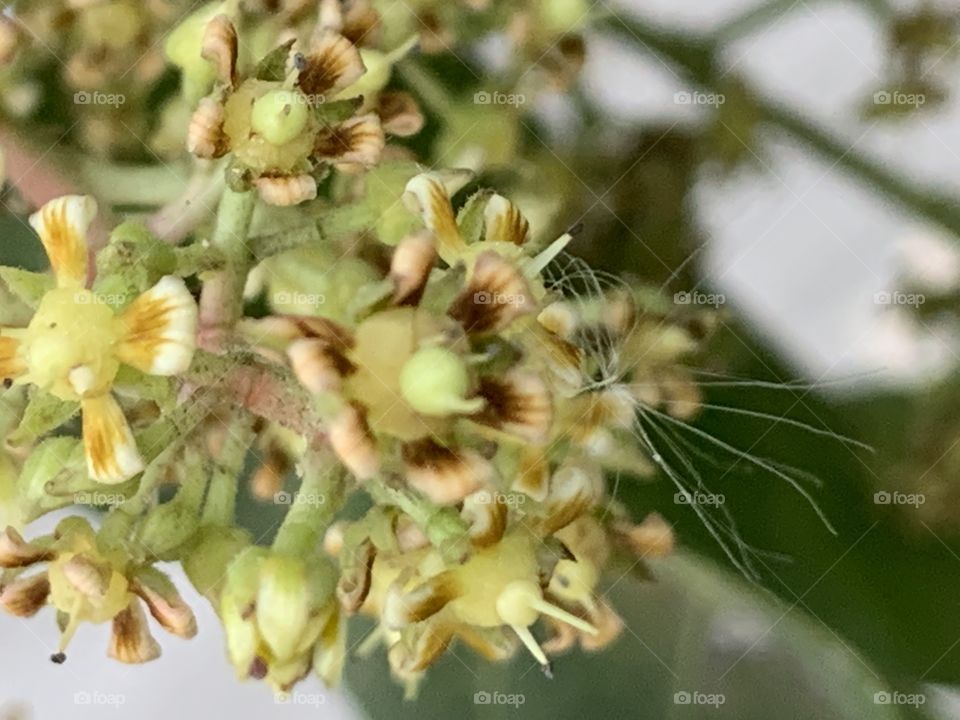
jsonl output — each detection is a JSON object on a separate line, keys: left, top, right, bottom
{"left": 603, "top": 17, "right": 960, "bottom": 236}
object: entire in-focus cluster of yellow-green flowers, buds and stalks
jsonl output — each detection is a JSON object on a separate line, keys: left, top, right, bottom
{"left": 0, "top": 2, "right": 698, "bottom": 694}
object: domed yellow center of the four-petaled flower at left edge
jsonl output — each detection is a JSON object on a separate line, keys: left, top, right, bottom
{"left": 24, "top": 288, "right": 120, "bottom": 400}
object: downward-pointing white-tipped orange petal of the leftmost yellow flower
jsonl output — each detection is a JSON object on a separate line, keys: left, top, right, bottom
{"left": 80, "top": 395, "right": 144, "bottom": 485}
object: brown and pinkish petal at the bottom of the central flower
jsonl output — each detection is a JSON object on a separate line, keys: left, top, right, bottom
{"left": 403, "top": 438, "right": 493, "bottom": 505}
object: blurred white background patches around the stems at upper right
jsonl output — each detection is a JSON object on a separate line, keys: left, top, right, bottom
{"left": 585, "top": 0, "right": 960, "bottom": 388}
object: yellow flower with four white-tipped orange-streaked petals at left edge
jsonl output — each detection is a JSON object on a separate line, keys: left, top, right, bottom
{"left": 0, "top": 195, "right": 197, "bottom": 483}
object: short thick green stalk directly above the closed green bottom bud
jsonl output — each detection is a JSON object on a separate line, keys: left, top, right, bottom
{"left": 273, "top": 450, "right": 344, "bottom": 556}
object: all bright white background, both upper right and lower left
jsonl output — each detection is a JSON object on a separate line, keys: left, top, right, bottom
{"left": 0, "top": 0, "right": 960, "bottom": 720}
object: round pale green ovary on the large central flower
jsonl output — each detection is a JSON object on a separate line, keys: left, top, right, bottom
{"left": 400, "top": 347, "right": 483, "bottom": 415}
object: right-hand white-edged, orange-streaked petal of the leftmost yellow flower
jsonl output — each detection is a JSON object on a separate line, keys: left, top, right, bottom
{"left": 116, "top": 275, "right": 197, "bottom": 376}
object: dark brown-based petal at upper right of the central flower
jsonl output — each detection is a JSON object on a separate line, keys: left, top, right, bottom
{"left": 449, "top": 251, "right": 536, "bottom": 334}
